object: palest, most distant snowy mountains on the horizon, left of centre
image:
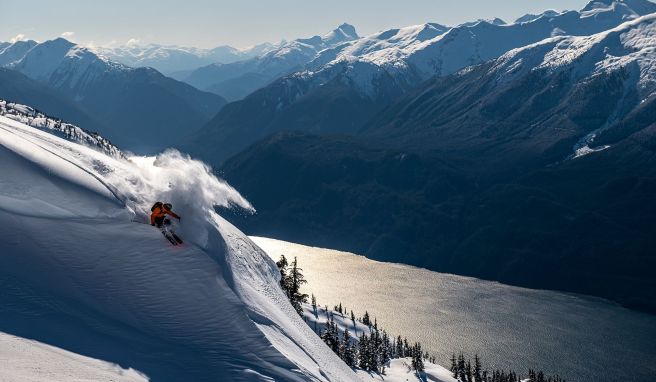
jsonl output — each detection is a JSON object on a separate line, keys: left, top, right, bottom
{"left": 94, "top": 43, "right": 274, "bottom": 74}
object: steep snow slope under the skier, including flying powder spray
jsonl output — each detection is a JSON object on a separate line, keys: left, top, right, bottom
{"left": 0, "top": 112, "right": 356, "bottom": 381}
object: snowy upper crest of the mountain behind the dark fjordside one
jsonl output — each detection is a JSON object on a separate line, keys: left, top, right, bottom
{"left": 290, "top": 0, "right": 656, "bottom": 98}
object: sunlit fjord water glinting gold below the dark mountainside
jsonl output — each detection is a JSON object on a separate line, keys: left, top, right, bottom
{"left": 252, "top": 237, "right": 656, "bottom": 382}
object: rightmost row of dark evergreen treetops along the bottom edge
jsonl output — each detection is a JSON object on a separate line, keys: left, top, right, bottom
{"left": 451, "top": 353, "right": 565, "bottom": 382}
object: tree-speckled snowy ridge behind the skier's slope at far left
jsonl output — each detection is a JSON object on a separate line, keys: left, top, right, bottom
{"left": 0, "top": 100, "right": 125, "bottom": 158}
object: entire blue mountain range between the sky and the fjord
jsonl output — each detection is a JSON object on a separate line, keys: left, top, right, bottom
{"left": 0, "top": 0, "right": 656, "bottom": 311}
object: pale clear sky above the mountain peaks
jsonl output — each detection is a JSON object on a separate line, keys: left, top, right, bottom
{"left": 0, "top": 0, "right": 588, "bottom": 48}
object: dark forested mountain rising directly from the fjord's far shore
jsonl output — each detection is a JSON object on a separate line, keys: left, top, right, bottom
{"left": 222, "top": 14, "right": 656, "bottom": 312}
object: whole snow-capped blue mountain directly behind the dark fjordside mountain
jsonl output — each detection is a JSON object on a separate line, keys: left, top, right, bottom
{"left": 184, "top": 0, "right": 656, "bottom": 164}
